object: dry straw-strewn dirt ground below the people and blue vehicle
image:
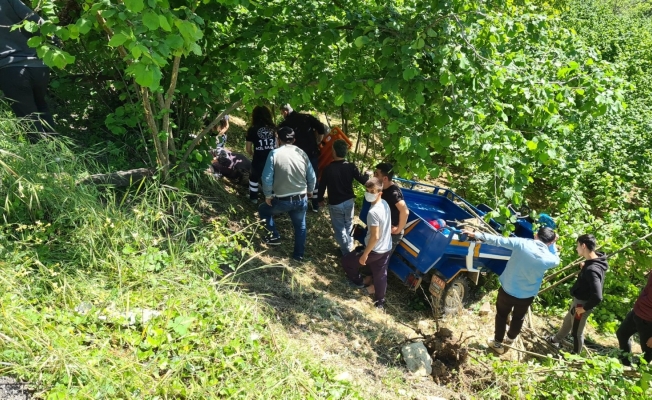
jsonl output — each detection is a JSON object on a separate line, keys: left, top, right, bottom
{"left": 205, "top": 117, "right": 640, "bottom": 399}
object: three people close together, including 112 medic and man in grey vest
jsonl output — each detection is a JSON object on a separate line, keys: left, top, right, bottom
{"left": 245, "top": 104, "right": 326, "bottom": 262}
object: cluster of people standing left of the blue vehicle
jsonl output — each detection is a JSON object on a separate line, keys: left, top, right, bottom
{"left": 246, "top": 104, "right": 409, "bottom": 309}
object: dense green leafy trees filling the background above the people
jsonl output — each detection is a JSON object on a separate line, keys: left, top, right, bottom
{"left": 30, "top": 0, "right": 652, "bottom": 310}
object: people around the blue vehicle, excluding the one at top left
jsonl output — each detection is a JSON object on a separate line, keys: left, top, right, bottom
{"left": 252, "top": 110, "right": 652, "bottom": 365}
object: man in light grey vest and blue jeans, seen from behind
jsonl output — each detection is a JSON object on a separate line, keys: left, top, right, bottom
{"left": 258, "top": 126, "right": 316, "bottom": 262}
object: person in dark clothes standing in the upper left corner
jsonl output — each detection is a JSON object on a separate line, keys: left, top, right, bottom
{"left": 0, "top": 0, "right": 54, "bottom": 142}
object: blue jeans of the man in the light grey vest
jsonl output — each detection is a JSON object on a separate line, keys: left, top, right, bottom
{"left": 258, "top": 196, "right": 308, "bottom": 259}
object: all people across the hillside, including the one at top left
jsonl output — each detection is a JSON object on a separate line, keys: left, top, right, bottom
{"left": 0, "top": 0, "right": 652, "bottom": 365}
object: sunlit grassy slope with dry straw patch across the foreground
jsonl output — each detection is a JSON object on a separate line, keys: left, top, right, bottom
{"left": 0, "top": 113, "right": 648, "bottom": 399}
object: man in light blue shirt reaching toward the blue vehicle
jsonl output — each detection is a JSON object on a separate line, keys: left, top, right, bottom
{"left": 465, "top": 227, "right": 559, "bottom": 354}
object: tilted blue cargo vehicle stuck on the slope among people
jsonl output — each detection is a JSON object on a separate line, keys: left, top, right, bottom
{"left": 360, "top": 179, "right": 554, "bottom": 314}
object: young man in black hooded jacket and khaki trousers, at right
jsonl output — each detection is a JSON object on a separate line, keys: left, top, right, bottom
{"left": 546, "top": 234, "right": 609, "bottom": 354}
